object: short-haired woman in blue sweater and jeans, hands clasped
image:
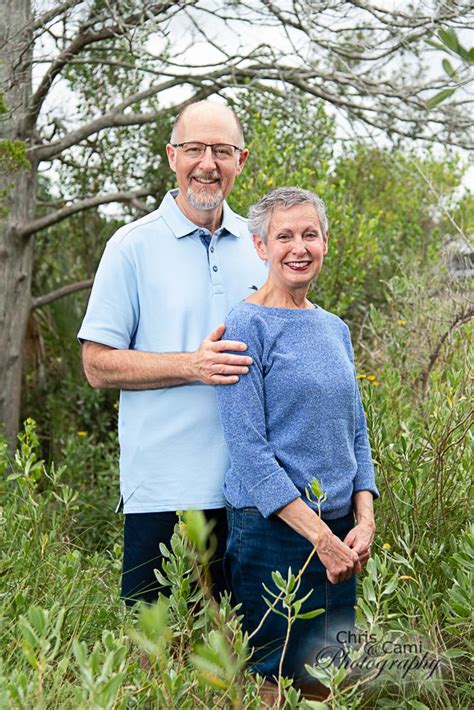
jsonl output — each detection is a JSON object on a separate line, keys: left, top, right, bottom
{"left": 217, "top": 187, "right": 378, "bottom": 683}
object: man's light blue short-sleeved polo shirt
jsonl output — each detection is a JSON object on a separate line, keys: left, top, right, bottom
{"left": 78, "top": 191, "right": 267, "bottom": 513}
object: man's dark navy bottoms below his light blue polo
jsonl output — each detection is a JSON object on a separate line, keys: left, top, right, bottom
{"left": 121, "top": 508, "right": 229, "bottom": 606}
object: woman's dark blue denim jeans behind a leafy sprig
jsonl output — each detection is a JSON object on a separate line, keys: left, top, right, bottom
{"left": 226, "top": 508, "right": 356, "bottom": 682}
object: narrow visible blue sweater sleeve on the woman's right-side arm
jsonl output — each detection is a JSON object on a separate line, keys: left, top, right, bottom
{"left": 344, "top": 325, "right": 379, "bottom": 498}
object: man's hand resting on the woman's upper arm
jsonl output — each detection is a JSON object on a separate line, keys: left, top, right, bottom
{"left": 192, "top": 323, "right": 252, "bottom": 385}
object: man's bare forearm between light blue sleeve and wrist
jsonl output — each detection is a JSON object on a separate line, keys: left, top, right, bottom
{"left": 83, "top": 343, "right": 198, "bottom": 390}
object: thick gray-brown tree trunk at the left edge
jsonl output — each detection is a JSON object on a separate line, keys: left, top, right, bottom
{"left": 0, "top": 0, "right": 36, "bottom": 446}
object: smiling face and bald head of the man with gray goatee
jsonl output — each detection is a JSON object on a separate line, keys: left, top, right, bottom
{"left": 166, "top": 104, "right": 248, "bottom": 211}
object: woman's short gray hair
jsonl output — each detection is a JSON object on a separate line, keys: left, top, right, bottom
{"left": 248, "top": 187, "right": 328, "bottom": 244}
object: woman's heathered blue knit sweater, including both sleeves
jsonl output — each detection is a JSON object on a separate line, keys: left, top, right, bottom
{"left": 216, "top": 301, "right": 378, "bottom": 519}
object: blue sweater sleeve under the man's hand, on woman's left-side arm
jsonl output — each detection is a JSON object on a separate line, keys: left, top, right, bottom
{"left": 216, "top": 308, "right": 300, "bottom": 518}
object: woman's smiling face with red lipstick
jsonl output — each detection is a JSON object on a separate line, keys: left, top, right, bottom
{"left": 254, "top": 203, "right": 328, "bottom": 291}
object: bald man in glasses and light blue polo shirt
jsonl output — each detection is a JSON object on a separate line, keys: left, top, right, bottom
{"left": 79, "top": 101, "right": 265, "bottom": 604}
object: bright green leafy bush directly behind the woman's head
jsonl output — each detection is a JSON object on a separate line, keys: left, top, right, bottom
{"left": 229, "top": 94, "right": 464, "bottom": 325}
